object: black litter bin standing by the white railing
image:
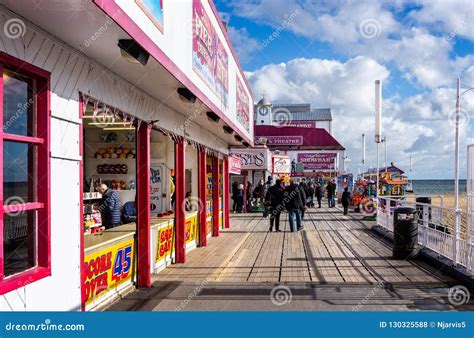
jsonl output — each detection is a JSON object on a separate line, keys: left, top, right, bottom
{"left": 393, "top": 207, "right": 418, "bottom": 259}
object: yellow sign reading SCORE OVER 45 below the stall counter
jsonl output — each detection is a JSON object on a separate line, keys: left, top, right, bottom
{"left": 83, "top": 239, "right": 134, "bottom": 305}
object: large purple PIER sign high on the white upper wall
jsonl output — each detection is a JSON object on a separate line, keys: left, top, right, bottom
{"left": 193, "top": 0, "right": 229, "bottom": 107}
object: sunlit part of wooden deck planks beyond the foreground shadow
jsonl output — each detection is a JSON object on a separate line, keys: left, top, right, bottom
{"left": 154, "top": 208, "right": 447, "bottom": 285}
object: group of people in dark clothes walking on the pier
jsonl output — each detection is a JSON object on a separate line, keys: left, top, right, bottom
{"left": 232, "top": 176, "right": 351, "bottom": 232}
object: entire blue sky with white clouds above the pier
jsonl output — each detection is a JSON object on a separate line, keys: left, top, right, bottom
{"left": 215, "top": 0, "right": 474, "bottom": 179}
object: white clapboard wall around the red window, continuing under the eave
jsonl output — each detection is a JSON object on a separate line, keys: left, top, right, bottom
{"left": 0, "top": 5, "right": 228, "bottom": 311}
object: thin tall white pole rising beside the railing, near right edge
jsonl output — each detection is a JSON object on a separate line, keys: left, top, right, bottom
{"left": 453, "top": 78, "right": 461, "bottom": 265}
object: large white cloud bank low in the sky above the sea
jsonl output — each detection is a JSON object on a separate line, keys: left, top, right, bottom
{"left": 247, "top": 57, "right": 474, "bottom": 178}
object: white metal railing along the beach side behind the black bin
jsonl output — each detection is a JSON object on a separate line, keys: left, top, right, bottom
{"left": 377, "top": 195, "right": 474, "bottom": 274}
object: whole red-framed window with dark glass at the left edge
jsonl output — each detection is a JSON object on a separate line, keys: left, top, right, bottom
{"left": 0, "top": 53, "right": 51, "bottom": 294}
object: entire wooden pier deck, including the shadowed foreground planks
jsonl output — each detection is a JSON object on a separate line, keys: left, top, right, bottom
{"left": 110, "top": 208, "right": 473, "bottom": 311}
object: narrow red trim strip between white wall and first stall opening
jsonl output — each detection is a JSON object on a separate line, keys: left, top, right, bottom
{"left": 79, "top": 94, "right": 86, "bottom": 312}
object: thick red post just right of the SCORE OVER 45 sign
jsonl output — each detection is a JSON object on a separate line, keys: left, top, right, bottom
{"left": 137, "top": 123, "right": 151, "bottom": 288}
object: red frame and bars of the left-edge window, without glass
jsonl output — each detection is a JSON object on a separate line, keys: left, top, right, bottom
{"left": 0, "top": 52, "right": 51, "bottom": 294}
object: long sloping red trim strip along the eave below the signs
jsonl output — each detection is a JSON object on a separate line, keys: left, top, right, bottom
{"left": 93, "top": 0, "right": 254, "bottom": 146}
